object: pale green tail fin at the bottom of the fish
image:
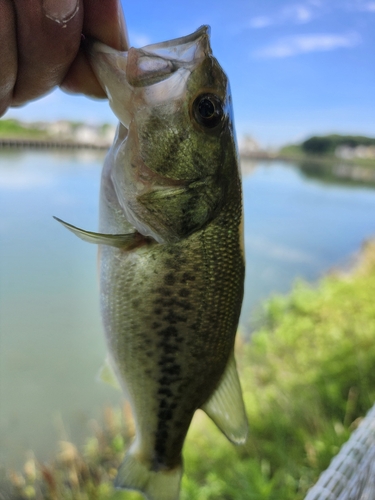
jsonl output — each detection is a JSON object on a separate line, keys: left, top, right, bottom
{"left": 114, "top": 451, "right": 182, "bottom": 500}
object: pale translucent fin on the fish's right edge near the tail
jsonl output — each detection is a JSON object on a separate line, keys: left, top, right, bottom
{"left": 202, "top": 352, "right": 248, "bottom": 444}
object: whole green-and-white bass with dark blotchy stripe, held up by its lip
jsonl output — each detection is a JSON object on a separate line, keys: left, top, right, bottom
{"left": 58, "top": 26, "right": 248, "bottom": 500}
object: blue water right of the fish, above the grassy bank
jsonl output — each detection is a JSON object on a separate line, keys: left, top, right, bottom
{"left": 242, "top": 161, "right": 375, "bottom": 327}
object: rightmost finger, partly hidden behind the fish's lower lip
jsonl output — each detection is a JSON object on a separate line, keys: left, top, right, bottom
{"left": 61, "top": 0, "right": 129, "bottom": 97}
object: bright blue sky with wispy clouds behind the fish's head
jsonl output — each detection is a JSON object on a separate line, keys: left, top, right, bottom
{"left": 5, "top": 0, "right": 375, "bottom": 147}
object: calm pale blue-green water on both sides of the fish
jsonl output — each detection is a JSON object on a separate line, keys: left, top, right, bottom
{"left": 0, "top": 152, "right": 375, "bottom": 467}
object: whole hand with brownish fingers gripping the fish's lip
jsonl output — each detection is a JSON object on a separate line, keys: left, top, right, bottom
{"left": 0, "top": 0, "right": 128, "bottom": 116}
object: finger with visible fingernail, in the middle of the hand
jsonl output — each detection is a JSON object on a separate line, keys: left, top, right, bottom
{"left": 13, "top": 0, "right": 83, "bottom": 105}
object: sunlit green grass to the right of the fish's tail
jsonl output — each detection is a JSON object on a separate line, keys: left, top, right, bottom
{"left": 182, "top": 244, "right": 375, "bottom": 500}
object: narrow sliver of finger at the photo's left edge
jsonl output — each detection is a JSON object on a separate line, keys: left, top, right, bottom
{"left": 0, "top": 0, "right": 17, "bottom": 116}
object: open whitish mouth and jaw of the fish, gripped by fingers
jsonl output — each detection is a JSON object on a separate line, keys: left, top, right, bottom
{"left": 85, "top": 26, "right": 212, "bottom": 128}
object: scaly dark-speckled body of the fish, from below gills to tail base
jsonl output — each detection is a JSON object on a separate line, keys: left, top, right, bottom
{"left": 101, "top": 213, "right": 243, "bottom": 470}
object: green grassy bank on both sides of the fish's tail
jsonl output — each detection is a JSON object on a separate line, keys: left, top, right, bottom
{"left": 2, "top": 243, "right": 375, "bottom": 500}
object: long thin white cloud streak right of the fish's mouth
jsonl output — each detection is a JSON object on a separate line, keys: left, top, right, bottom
{"left": 253, "top": 33, "right": 361, "bottom": 58}
